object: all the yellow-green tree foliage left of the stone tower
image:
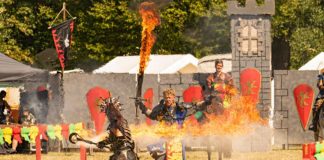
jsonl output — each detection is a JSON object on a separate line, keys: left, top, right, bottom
{"left": 0, "top": 0, "right": 230, "bottom": 68}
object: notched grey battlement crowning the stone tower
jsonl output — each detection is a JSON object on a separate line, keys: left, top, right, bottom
{"left": 227, "top": 0, "right": 275, "bottom": 15}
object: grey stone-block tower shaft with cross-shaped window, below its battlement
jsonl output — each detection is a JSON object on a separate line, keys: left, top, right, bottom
{"left": 231, "top": 15, "right": 272, "bottom": 118}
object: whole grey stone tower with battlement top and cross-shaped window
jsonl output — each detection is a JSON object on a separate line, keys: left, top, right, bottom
{"left": 227, "top": 0, "right": 275, "bottom": 118}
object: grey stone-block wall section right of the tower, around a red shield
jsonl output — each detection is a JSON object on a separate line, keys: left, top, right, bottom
{"left": 273, "top": 70, "right": 318, "bottom": 148}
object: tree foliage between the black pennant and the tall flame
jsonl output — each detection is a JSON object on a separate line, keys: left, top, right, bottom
{"left": 77, "top": 0, "right": 141, "bottom": 62}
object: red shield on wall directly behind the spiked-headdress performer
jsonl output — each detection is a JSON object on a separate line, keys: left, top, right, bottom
{"left": 86, "top": 87, "right": 110, "bottom": 134}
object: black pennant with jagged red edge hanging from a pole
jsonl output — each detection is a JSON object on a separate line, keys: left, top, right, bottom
{"left": 52, "top": 19, "right": 74, "bottom": 70}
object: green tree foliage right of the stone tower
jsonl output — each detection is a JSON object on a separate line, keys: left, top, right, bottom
{"left": 272, "top": 0, "right": 324, "bottom": 69}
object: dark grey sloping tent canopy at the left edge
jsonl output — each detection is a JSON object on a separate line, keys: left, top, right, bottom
{"left": 0, "top": 53, "right": 46, "bottom": 82}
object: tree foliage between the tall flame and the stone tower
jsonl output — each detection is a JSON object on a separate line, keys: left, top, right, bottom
{"left": 154, "top": 0, "right": 231, "bottom": 57}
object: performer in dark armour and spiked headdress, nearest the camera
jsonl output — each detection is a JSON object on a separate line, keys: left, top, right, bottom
{"left": 97, "top": 98, "right": 138, "bottom": 160}
